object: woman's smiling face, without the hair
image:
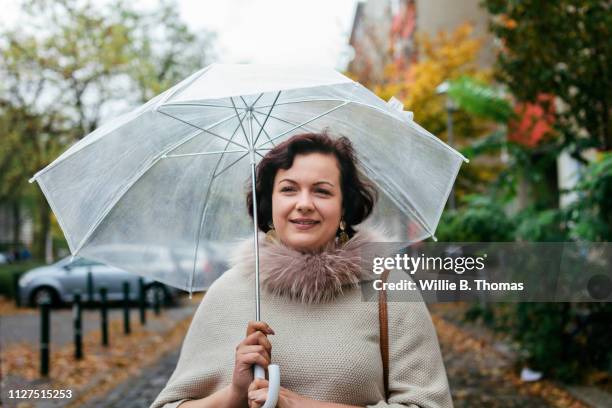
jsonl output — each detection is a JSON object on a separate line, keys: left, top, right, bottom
{"left": 272, "top": 153, "right": 342, "bottom": 251}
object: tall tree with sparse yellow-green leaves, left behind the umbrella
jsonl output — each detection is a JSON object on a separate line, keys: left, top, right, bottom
{"left": 0, "top": 0, "right": 211, "bottom": 257}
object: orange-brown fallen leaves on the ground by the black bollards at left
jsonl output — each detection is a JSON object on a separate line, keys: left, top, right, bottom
{"left": 0, "top": 296, "right": 201, "bottom": 407}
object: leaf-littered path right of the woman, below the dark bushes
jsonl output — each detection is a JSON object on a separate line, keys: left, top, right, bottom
{"left": 430, "top": 304, "right": 612, "bottom": 408}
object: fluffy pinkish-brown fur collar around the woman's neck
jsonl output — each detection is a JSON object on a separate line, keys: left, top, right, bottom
{"left": 232, "top": 230, "right": 389, "bottom": 304}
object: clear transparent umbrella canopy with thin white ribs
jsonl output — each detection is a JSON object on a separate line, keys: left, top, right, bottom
{"left": 33, "top": 64, "right": 465, "bottom": 291}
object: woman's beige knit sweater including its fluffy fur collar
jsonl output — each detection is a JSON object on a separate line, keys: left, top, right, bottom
{"left": 151, "top": 233, "right": 452, "bottom": 408}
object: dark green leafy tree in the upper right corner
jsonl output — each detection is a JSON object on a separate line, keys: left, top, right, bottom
{"left": 484, "top": 0, "right": 612, "bottom": 156}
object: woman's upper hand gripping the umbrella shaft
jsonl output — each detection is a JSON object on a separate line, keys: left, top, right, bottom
{"left": 231, "top": 321, "right": 274, "bottom": 396}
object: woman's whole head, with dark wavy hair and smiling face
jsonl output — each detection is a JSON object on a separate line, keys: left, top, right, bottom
{"left": 247, "top": 133, "right": 376, "bottom": 252}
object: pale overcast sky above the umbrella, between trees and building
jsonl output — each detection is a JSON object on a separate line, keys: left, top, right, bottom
{"left": 0, "top": 0, "right": 357, "bottom": 69}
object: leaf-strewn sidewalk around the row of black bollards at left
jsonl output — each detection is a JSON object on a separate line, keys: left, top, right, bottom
{"left": 0, "top": 296, "right": 201, "bottom": 408}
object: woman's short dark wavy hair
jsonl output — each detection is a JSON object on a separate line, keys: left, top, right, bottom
{"left": 246, "top": 132, "right": 378, "bottom": 237}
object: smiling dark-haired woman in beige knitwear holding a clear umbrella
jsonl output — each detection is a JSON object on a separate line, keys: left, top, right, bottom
{"left": 152, "top": 134, "right": 452, "bottom": 408}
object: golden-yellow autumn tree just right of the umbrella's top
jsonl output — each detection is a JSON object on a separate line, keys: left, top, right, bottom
{"left": 373, "top": 23, "right": 500, "bottom": 198}
